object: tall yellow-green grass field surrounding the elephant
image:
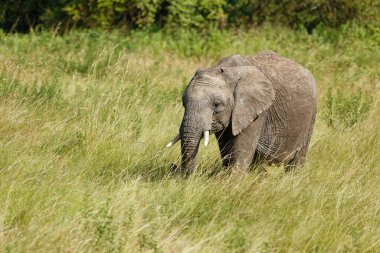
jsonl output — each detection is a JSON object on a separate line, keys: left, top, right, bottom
{"left": 0, "top": 27, "right": 380, "bottom": 252}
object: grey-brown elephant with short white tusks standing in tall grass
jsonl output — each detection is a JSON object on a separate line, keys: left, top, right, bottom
{"left": 167, "top": 52, "right": 317, "bottom": 174}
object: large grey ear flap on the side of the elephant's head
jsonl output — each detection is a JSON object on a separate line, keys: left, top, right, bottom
{"left": 221, "top": 66, "right": 275, "bottom": 135}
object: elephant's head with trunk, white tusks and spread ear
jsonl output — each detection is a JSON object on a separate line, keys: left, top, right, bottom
{"left": 167, "top": 59, "right": 275, "bottom": 173}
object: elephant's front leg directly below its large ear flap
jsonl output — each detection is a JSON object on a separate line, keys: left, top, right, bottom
{"left": 231, "top": 113, "right": 266, "bottom": 170}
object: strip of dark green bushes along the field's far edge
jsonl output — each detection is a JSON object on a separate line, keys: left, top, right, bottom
{"left": 0, "top": 0, "right": 380, "bottom": 33}
